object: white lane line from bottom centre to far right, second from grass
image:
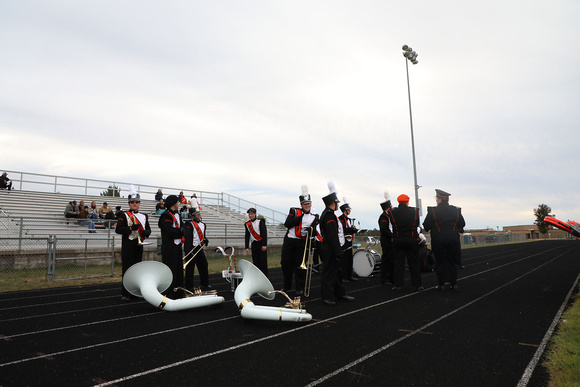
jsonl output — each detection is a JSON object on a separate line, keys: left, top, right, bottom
{"left": 306, "top": 251, "right": 574, "bottom": 387}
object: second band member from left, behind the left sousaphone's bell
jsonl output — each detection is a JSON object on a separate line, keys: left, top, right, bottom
{"left": 158, "top": 195, "right": 183, "bottom": 299}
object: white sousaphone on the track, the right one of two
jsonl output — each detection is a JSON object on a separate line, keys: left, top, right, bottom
{"left": 234, "top": 259, "right": 312, "bottom": 322}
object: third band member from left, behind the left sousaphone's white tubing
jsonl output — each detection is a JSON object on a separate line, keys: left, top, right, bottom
{"left": 183, "top": 207, "right": 211, "bottom": 291}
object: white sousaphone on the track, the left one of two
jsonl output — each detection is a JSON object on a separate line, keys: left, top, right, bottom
{"left": 123, "top": 261, "right": 224, "bottom": 312}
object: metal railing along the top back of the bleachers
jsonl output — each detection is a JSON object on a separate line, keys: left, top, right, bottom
{"left": 2, "top": 170, "right": 286, "bottom": 226}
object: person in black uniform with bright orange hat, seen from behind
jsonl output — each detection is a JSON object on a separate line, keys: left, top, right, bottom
{"left": 387, "top": 194, "right": 423, "bottom": 291}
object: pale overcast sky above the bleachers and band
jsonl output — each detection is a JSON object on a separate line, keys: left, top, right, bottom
{"left": 0, "top": 0, "right": 580, "bottom": 228}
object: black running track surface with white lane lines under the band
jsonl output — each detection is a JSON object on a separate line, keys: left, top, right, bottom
{"left": 0, "top": 241, "right": 580, "bottom": 386}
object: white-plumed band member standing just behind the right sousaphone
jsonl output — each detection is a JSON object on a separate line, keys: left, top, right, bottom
{"left": 280, "top": 185, "right": 318, "bottom": 296}
